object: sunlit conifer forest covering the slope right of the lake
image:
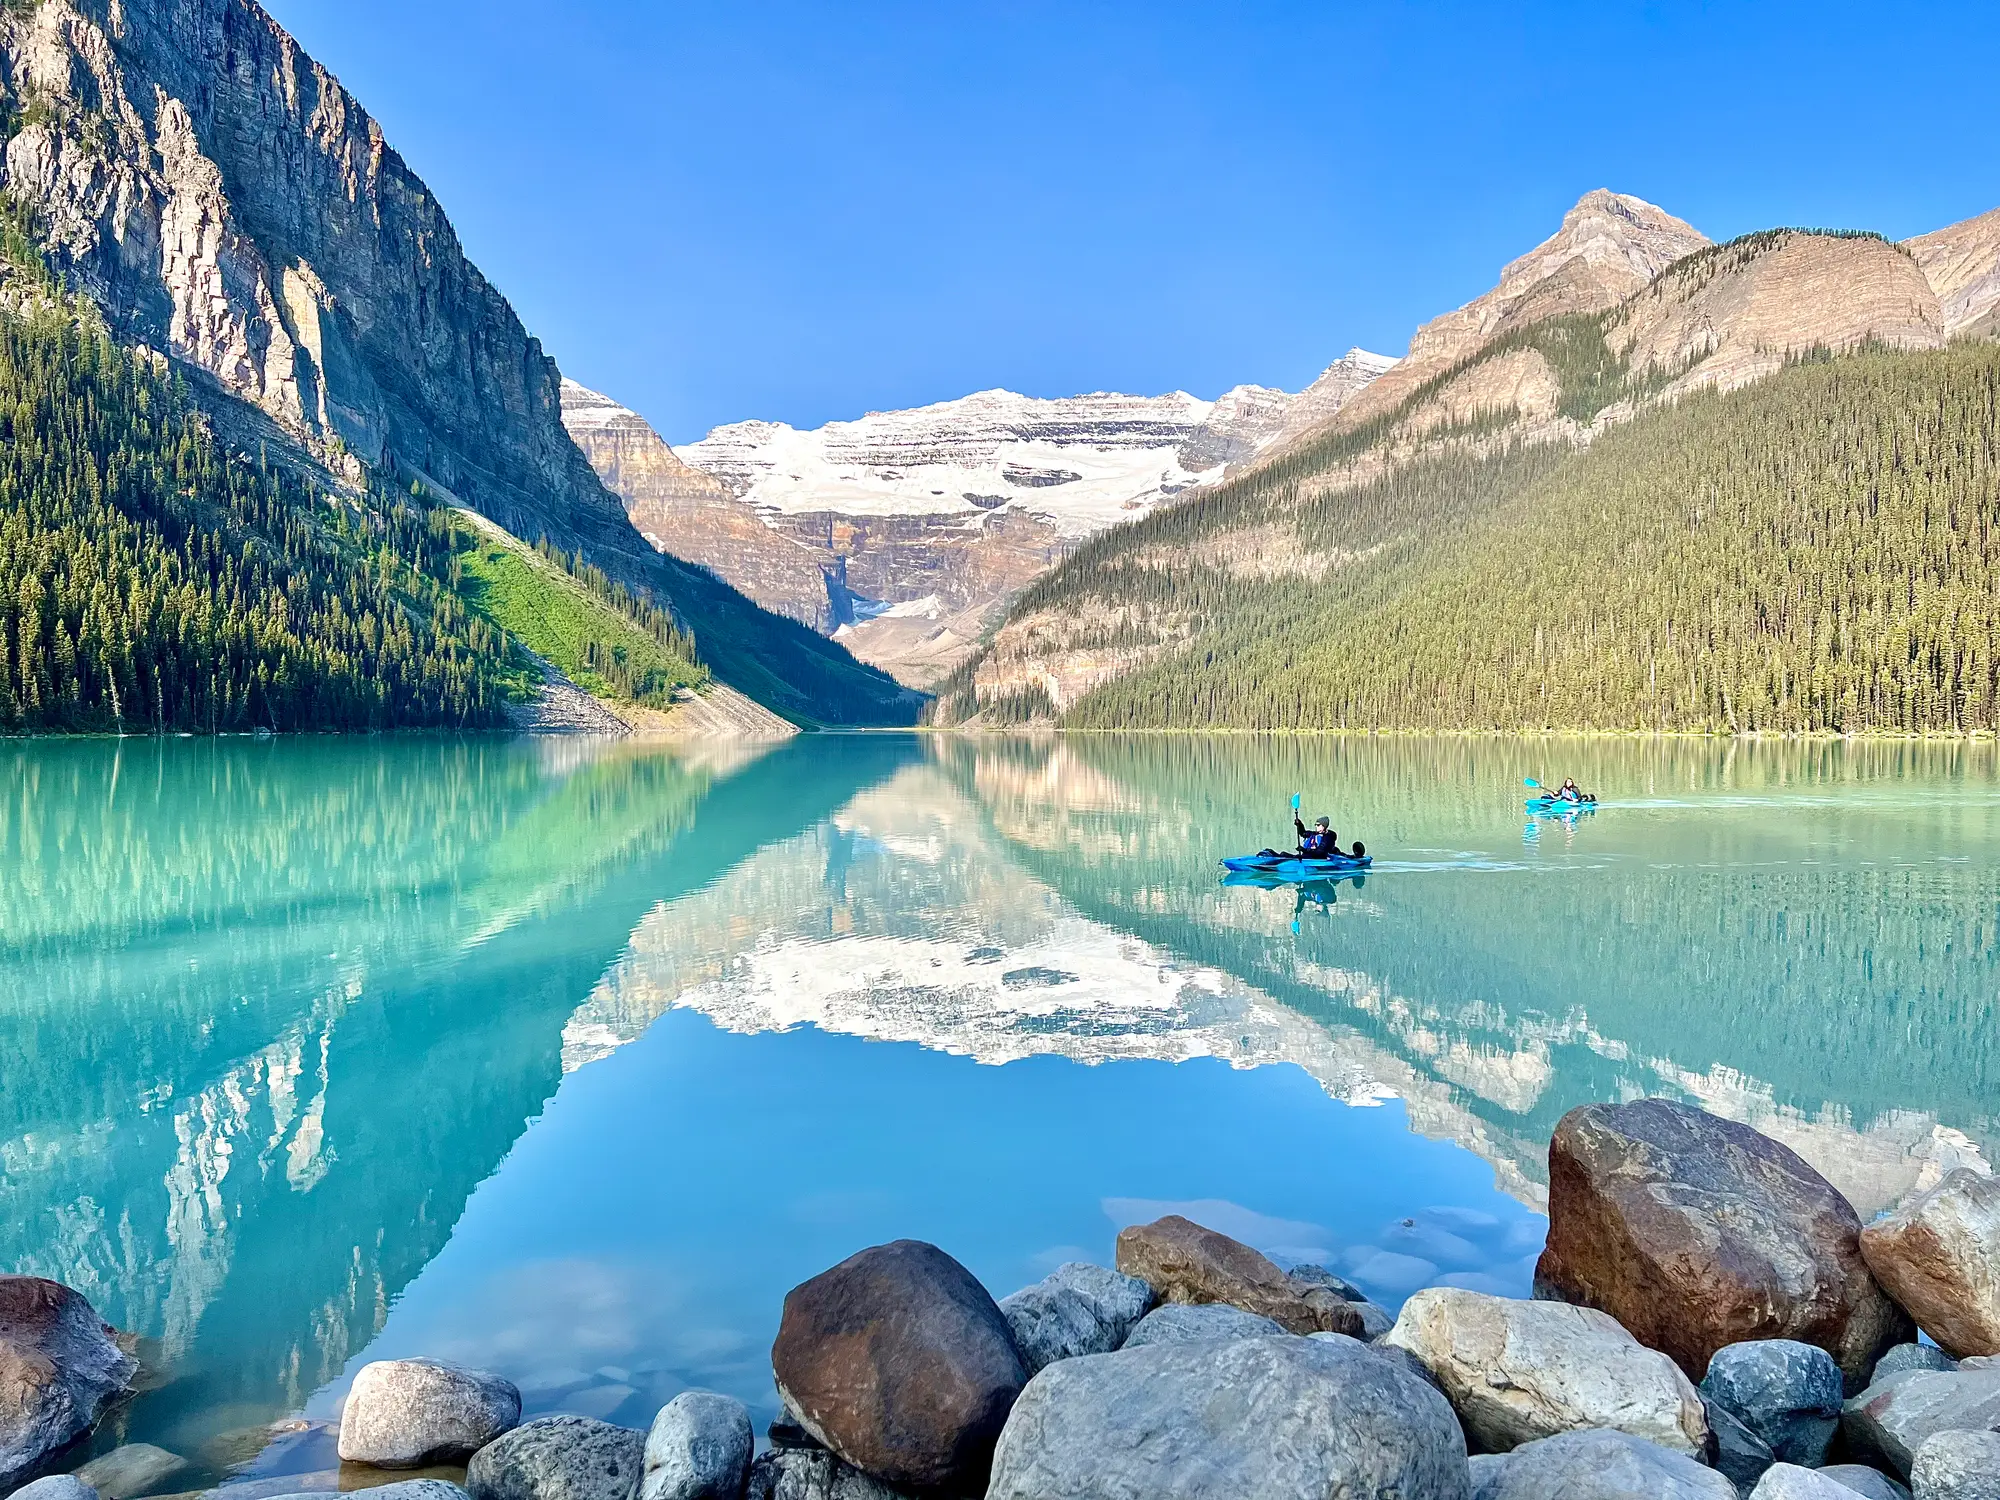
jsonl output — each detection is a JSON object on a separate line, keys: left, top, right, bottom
{"left": 944, "top": 342, "right": 2000, "bottom": 734}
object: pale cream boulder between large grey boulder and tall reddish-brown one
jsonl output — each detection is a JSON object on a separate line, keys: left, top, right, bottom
{"left": 1382, "top": 1286, "right": 1708, "bottom": 1454}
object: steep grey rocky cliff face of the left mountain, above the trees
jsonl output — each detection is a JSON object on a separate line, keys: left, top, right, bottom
{"left": 0, "top": 0, "right": 912, "bottom": 736}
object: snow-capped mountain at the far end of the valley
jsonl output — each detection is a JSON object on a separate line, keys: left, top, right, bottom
{"left": 564, "top": 370, "right": 1394, "bottom": 686}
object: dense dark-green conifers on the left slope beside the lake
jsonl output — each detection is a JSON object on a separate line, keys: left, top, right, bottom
{"left": 0, "top": 312, "right": 508, "bottom": 734}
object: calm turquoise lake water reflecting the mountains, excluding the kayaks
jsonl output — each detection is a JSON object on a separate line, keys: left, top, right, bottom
{"left": 0, "top": 736, "right": 2000, "bottom": 1490}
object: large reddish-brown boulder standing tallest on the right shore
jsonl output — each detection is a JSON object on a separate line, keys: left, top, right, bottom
{"left": 1534, "top": 1100, "right": 1914, "bottom": 1390}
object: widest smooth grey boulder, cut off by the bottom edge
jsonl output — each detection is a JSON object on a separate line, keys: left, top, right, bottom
{"left": 986, "top": 1336, "right": 1472, "bottom": 1500}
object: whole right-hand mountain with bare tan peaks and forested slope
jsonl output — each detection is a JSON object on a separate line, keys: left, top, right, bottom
{"left": 936, "top": 192, "right": 2000, "bottom": 732}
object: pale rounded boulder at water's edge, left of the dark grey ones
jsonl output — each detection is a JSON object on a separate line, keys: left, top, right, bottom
{"left": 340, "top": 1360, "right": 520, "bottom": 1468}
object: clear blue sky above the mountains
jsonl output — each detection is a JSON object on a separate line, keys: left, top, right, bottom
{"left": 266, "top": 0, "right": 2000, "bottom": 442}
